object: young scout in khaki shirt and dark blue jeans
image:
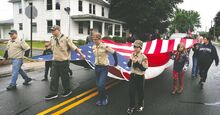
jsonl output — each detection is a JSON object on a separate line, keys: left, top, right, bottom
{"left": 92, "top": 33, "right": 118, "bottom": 106}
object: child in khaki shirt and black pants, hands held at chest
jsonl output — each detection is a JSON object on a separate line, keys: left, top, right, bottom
{"left": 127, "top": 40, "right": 148, "bottom": 114}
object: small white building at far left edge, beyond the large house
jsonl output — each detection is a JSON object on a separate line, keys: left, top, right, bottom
{"left": 0, "top": 19, "right": 13, "bottom": 39}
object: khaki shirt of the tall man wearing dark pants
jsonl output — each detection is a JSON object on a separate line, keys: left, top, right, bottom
{"left": 50, "top": 34, "right": 77, "bottom": 61}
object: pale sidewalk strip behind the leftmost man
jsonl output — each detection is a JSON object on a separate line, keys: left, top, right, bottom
{"left": 0, "top": 62, "right": 44, "bottom": 78}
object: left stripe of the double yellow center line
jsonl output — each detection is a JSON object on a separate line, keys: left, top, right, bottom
{"left": 37, "top": 80, "right": 115, "bottom": 115}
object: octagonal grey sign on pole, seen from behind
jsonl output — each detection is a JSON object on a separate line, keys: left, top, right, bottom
{"left": 25, "top": 5, "right": 38, "bottom": 19}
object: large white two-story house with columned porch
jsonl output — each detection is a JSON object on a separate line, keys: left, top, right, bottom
{"left": 9, "top": 0, "right": 124, "bottom": 41}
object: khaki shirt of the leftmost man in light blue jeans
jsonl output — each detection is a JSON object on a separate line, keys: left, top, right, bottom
{"left": 6, "top": 38, "right": 30, "bottom": 59}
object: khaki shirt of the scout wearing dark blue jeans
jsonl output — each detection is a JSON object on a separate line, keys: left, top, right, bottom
{"left": 92, "top": 42, "right": 115, "bottom": 66}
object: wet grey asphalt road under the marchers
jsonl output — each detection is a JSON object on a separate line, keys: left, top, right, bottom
{"left": 0, "top": 47, "right": 220, "bottom": 115}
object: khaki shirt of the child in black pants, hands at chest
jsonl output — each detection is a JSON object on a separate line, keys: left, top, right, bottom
{"left": 130, "top": 53, "right": 148, "bottom": 75}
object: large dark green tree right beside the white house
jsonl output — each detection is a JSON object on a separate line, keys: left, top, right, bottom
{"left": 110, "top": 0, "right": 183, "bottom": 34}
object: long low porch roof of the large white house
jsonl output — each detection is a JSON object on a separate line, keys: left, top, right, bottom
{"left": 71, "top": 14, "right": 125, "bottom": 24}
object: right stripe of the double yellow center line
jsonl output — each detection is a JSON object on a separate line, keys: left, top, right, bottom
{"left": 52, "top": 81, "right": 120, "bottom": 115}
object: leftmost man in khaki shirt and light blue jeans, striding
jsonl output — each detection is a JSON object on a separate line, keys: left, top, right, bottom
{"left": 4, "top": 30, "right": 32, "bottom": 90}
